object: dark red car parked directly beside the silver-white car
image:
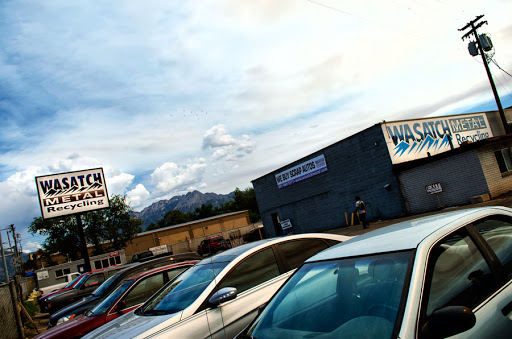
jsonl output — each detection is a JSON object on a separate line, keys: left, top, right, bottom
{"left": 36, "top": 260, "right": 198, "bottom": 339}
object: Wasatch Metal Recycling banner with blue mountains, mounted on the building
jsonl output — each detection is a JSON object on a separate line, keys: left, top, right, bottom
{"left": 381, "top": 113, "right": 493, "bottom": 164}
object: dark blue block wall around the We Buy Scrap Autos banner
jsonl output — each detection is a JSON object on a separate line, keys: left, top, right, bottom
{"left": 252, "top": 125, "right": 405, "bottom": 236}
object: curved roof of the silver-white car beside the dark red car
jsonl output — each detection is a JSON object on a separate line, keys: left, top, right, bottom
{"left": 198, "top": 233, "right": 350, "bottom": 265}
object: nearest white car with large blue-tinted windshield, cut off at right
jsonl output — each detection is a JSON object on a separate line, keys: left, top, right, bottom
{"left": 242, "top": 207, "right": 512, "bottom": 339}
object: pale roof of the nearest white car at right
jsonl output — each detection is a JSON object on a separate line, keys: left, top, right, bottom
{"left": 306, "top": 206, "right": 512, "bottom": 262}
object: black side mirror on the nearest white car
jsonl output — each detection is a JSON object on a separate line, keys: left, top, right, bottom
{"left": 421, "top": 306, "right": 476, "bottom": 338}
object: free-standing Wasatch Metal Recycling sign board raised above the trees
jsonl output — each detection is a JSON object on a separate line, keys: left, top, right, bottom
{"left": 36, "top": 168, "right": 109, "bottom": 219}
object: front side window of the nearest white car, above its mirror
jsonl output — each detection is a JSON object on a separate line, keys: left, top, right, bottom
{"left": 425, "top": 230, "right": 497, "bottom": 316}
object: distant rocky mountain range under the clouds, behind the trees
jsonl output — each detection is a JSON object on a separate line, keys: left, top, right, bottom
{"left": 135, "top": 191, "right": 233, "bottom": 229}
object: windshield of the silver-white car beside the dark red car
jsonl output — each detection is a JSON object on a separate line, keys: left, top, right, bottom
{"left": 139, "top": 262, "right": 229, "bottom": 315}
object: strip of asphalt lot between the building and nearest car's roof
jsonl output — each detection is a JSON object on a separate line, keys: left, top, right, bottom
{"left": 326, "top": 192, "right": 512, "bottom": 236}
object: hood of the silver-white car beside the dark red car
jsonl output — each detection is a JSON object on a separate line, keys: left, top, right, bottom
{"left": 82, "top": 311, "right": 182, "bottom": 339}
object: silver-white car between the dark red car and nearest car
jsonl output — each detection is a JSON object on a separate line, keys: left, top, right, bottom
{"left": 84, "top": 233, "right": 350, "bottom": 339}
